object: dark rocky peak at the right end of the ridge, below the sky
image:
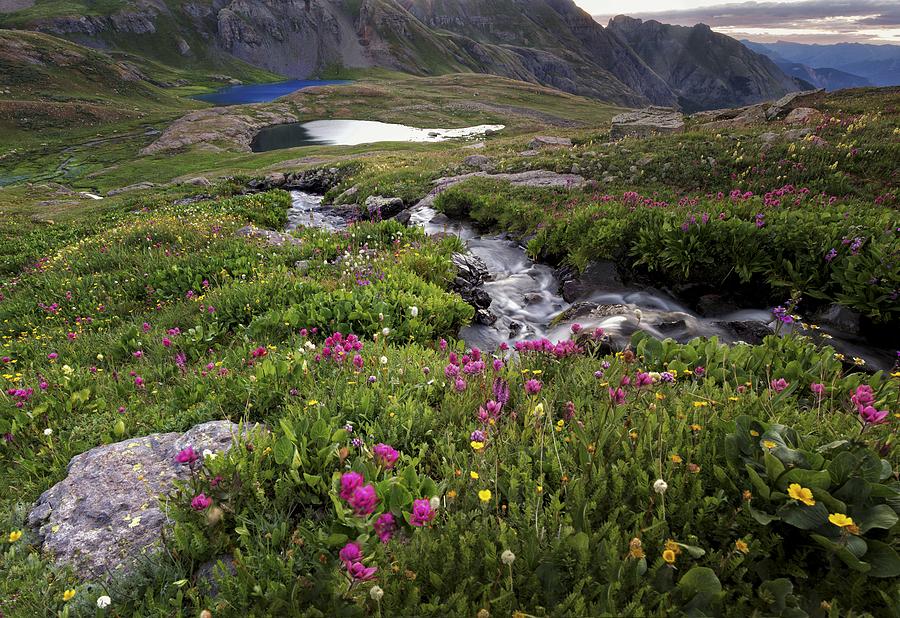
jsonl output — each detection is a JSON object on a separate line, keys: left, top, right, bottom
{"left": 608, "top": 15, "right": 799, "bottom": 111}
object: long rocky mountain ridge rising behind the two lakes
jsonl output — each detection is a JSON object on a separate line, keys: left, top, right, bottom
{"left": 0, "top": 0, "right": 804, "bottom": 111}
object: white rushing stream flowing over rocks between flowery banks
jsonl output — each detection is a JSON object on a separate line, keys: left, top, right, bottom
{"left": 287, "top": 191, "right": 893, "bottom": 369}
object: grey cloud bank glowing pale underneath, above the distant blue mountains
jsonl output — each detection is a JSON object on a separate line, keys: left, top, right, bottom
{"left": 601, "top": 0, "right": 900, "bottom": 43}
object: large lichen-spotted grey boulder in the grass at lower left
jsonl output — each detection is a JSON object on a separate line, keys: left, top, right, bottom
{"left": 28, "top": 421, "right": 256, "bottom": 580}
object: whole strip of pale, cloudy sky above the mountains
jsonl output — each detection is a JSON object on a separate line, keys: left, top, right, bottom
{"left": 575, "top": 0, "right": 900, "bottom": 44}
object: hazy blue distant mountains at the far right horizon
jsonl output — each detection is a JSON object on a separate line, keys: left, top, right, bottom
{"left": 741, "top": 41, "right": 900, "bottom": 90}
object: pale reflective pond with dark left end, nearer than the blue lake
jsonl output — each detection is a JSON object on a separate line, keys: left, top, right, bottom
{"left": 250, "top": 120, "right": 504, "bottom": 152}
